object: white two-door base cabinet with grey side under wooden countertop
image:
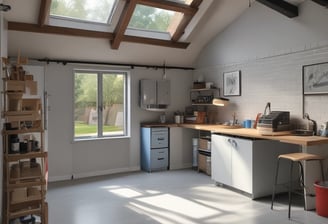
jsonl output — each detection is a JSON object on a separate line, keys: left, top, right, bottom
{"left": 211, "top": 134, "right": 299, "bottom": 198}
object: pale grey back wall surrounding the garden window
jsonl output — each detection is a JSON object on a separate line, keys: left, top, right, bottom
{"left": 45, "top": 63, "right": 192, "bottom": 181}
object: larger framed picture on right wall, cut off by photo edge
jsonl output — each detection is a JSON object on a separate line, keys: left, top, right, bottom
{"left": 303, "top": 62, "right": 328, "bottom": 95}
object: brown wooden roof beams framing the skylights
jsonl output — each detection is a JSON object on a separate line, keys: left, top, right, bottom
{"left": 8, "top": 0, "right": 203, "bottom": 49}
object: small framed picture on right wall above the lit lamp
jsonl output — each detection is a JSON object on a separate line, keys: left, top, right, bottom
{"left": 223, "top": 70, "right": 241, "bottom": 96}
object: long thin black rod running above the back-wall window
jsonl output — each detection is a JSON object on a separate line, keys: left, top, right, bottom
{"left": 34, "top": 58, "right": 195, "bottom": 70}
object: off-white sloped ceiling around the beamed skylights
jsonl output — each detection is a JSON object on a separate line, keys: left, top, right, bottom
{"left": 3, "top": 0, "right": 304, "bottom": 67}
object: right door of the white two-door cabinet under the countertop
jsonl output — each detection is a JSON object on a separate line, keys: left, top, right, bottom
{"left": 229, "top": 138, "right": 253, "bottom": 194}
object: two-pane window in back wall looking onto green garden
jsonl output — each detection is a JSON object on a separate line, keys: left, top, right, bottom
{"left": 74, "top": 70, "right": 129, "bottom": 140}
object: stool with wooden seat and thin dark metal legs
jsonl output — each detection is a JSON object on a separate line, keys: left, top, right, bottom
{"left": 271, "top": 153, "right": 325, "bottom": 219}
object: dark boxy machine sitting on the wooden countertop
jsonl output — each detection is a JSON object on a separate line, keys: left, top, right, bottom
{"left": 257, "top": 111, "right": 290, "bottom": 132}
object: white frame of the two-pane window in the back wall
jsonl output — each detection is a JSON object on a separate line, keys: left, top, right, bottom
{"left": 73, "top": 68, "right": 131, "bottom": 142}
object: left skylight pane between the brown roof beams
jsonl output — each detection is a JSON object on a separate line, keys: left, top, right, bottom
{"left": 50, "top": 0, "right": 116, "bottom": 23}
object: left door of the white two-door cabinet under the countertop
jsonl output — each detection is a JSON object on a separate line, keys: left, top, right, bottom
{"left": 211, "top": 134, "right": 232, "bottom": 186}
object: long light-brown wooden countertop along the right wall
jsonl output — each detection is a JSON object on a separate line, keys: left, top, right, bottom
{"left": 178, "top": 124, "right": 328, "bottom": 146}
